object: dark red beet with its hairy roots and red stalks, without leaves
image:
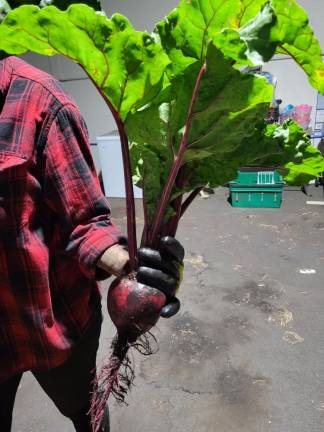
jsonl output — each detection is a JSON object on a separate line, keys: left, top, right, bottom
{"left": 90, "top": 60, "right": 206, "bottom": 432}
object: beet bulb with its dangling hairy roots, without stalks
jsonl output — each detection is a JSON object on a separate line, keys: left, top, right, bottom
{"left": 90, "top": 272, "right": 166, "bottom": 432}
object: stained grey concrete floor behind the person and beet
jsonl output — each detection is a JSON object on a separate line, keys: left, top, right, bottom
{"left": 13, "top": 188, "right": 324, "bottom": 432}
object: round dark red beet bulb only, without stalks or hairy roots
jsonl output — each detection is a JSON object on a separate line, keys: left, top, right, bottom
{"left": 108, "top": 277, "right": 166, "bottom": 339}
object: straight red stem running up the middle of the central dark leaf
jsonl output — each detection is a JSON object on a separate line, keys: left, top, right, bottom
{"left": 149, "top": 63, "right": 206, "bottom": 247}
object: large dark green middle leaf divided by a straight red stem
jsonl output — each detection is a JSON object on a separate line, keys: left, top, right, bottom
{"left": 126, "top": 45, "right": 273, "bottom": 220}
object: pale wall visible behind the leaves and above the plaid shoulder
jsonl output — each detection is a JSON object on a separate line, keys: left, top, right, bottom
{"left": 21, "top": 0, "right": 324, "bottom": 141}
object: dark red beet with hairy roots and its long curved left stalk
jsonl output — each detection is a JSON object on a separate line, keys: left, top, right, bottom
{"left": 89, "top": 73, "right": 166, "bottom": 432}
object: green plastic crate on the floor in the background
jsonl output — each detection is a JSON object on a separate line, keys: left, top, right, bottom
{"left": 229, "top": 169, "right": 284, "bottom": 208}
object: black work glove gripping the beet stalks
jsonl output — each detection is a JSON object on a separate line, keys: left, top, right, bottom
{"left": 137, "top": 236, "right": 184, "bottom": 318}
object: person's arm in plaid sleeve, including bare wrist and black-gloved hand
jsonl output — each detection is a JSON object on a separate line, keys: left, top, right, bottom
{"left": 43, "top": 104, "right": 184, "bottom": 317}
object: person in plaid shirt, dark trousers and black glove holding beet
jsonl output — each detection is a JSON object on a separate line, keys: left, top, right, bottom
{"left": 0, "top": 57, "right": 184, "bottom": 432}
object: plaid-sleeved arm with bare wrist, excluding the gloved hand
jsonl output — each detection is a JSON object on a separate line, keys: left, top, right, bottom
{"left": 43, "top": 104, "right": 128, "bottom": 279}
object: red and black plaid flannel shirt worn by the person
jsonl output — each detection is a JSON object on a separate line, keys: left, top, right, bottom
{"left": 0, "top": 57, "right": 126, "bottom": 380}
